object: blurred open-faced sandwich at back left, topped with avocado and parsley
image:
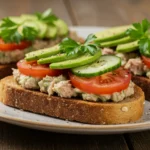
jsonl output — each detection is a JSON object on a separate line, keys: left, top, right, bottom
{"left": 0, "top": 9, "right": 80, "bottom": 78}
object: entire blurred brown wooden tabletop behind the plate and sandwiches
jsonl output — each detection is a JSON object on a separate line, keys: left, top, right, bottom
{"left": 0, "top": 0, "right": 150, "bottom": 26}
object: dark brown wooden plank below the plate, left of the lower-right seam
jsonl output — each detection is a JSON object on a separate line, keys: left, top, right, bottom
{"left": 0, "top": 122, "right": 128, "bottom": 150}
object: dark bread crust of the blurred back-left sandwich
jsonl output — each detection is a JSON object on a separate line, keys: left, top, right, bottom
{"left": 0, "top": 63, "right": 16, "bottom": 79}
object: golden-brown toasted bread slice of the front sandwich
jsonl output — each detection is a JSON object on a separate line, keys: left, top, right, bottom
{"left": 0, "top": 76, "right": 144, "bottom": 124}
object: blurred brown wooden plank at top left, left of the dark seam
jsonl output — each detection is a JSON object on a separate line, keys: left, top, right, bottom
{"left": 0, "top": 0, "right": 72, "bottom": 25}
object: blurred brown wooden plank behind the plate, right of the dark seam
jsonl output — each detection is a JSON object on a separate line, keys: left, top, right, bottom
{"left": 65, "top": 0, "right": 150, "bottom": 26}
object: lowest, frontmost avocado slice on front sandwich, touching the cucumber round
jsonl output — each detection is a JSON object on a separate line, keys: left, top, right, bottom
{"left": 50, "top": 51, "right": 101, "bottom": 69}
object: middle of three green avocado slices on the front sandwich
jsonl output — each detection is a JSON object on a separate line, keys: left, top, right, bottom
{"left": 38, "top": 54, "right": 79, "bottom": 64}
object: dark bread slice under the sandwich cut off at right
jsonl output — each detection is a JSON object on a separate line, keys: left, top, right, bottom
{"left": 132, "top": 76, "right": 150, "bottom": 101}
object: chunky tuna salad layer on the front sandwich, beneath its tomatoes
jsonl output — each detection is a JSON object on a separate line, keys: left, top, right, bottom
{"left": 13, "top": 69, "right": 134, "bottom": 102}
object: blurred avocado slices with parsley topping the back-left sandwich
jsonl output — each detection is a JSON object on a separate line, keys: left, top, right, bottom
{"left": 0, "top": 9, "right": 69, "bottom": 43}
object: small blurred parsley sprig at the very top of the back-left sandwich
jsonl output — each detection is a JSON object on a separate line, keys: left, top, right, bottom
{"left": 35, "top": 9, "right": 58, "bottom": 25}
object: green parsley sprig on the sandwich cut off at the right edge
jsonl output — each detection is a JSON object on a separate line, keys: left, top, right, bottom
{"left": 126, "top": 19, "right": 150, "bottom": 57}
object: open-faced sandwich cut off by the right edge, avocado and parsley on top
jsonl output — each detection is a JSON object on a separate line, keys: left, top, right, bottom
{"left": 95, "top": 19, "right": 150, "bottom": 100}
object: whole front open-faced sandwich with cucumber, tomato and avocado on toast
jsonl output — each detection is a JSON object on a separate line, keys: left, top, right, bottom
{"left": 0, "top": 34, "right": 144, "bottom": 124}
